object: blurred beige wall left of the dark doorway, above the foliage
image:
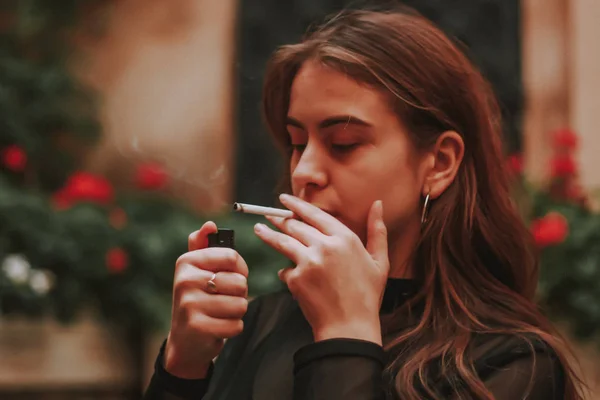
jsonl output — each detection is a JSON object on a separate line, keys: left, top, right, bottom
{"left": 82, "top": 0, "right": 236, "bottom": 212}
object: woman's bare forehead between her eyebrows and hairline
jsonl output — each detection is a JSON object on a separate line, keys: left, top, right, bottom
{"left": 288, "top": 61, "right": 392, "bottom": 120}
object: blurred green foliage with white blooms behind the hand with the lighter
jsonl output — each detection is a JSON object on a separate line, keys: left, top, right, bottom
{"left": 0, "top": 172, "right": 285, "bottom": 330}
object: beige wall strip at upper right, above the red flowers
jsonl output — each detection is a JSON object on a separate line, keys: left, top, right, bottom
{"left": 522, "top": 0, "right": 600, "bottom": 189}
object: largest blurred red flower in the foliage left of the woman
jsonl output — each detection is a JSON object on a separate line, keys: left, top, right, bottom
{"left": 53, "top": 171, "right": 114, "bottom": 208}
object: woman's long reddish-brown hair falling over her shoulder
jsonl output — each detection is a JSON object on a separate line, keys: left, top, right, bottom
{"left": 263, "top": 4, "right": 580, "bottom": 399}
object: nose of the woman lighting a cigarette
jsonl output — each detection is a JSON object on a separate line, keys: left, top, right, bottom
{"left": 291, "top": 142, "right": 327, "bottom": 193}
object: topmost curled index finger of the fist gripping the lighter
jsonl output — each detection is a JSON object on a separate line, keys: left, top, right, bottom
{"left": 177, "top": 247, "right": 248, "bottom": 278}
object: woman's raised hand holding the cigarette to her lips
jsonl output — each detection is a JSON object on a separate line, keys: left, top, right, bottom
{"left": 250, "top": 195, "right": 389, "bottom": 344}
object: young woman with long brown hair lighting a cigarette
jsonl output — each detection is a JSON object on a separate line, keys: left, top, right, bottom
{"left": 146, "top": 6, "right": 581, "bottom": 400}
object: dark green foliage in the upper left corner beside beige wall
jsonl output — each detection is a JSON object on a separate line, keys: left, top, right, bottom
{"left": 0, "top": 0, "right": 100, "bottom": 191}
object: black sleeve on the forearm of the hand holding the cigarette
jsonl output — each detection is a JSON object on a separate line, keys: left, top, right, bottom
{"left": 294, "top": 339, "right": 386, "bottom": 400}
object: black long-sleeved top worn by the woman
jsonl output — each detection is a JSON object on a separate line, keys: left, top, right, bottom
{"left": 144, "top": 279, "right": 564, "bottom": 400}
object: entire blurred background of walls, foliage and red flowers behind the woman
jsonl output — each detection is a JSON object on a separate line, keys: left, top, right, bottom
{"left": 0, "top": 0, "right": 600, "bottom": 399}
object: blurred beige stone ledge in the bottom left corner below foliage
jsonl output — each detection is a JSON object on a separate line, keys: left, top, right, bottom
{"left": 0, "top": 318, "right": 135, "bottom": 390}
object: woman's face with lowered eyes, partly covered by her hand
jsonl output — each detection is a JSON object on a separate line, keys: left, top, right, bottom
{"left": 287, "top": 62, "right": 424, "bottom": 241}
